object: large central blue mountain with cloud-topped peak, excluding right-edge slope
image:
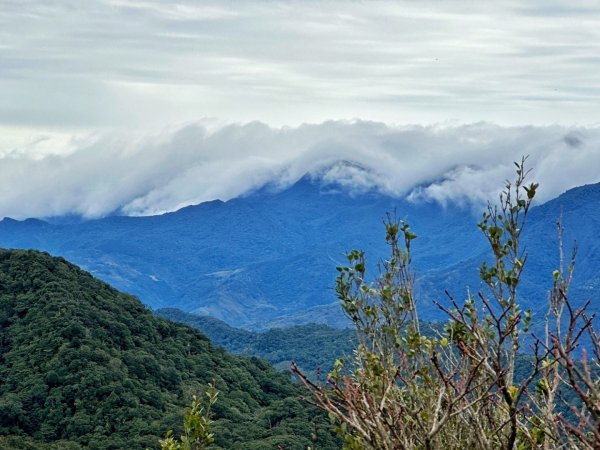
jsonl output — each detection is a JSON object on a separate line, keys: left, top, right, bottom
{"left": 0, "top": 174, "right": 483, "bottom": 328}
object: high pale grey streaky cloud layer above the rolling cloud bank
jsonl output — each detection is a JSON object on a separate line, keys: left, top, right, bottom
{"left": 0, "top": 0, "right": 600, "bottom": 129}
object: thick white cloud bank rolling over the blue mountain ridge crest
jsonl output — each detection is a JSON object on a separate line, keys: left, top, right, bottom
{"left": 0, "top": 121, "right": 600, "bottom": 218}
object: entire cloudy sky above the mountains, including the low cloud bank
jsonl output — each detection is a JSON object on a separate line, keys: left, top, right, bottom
{"left": 0, "top": 0, "right": 600, "bottom": 218}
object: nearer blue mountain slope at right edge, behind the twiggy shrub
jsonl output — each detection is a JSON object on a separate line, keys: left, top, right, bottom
{"left": 421, "top": 184, "right": 600, "bottom": 322}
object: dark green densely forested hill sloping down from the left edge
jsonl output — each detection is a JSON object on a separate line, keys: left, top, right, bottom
{"left": 0, "top": 250, "right": 338, "bottom": 449}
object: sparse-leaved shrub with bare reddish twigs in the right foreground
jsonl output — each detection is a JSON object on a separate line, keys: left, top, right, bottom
{"left": 292, "top": 159, "right": 600, "bottom": 450}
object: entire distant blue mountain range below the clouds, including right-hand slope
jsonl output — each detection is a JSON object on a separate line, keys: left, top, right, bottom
{"left": 0, "top": 171, "right": 600, "bottom": 329}
